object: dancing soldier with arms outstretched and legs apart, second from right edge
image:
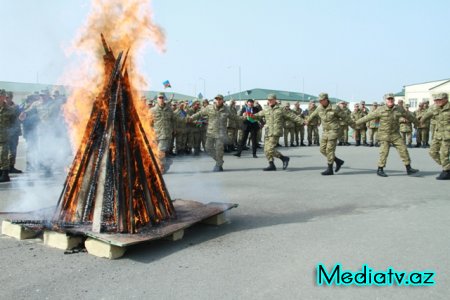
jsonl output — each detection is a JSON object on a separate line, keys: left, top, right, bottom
{"left": 356, "top": 93, "right": 419, "bottom": 177}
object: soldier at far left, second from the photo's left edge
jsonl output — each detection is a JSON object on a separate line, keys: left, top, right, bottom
{"left": 6, "top": 92, "right": 22, "bottom": 174}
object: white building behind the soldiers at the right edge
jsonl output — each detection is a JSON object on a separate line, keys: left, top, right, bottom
{"left": 404, "top": 79, "right": 450, "bottom": 111}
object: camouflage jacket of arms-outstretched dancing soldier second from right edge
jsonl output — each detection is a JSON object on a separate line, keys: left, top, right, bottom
{"left": 356, "top": 105, "right": 417, "bottom": 141}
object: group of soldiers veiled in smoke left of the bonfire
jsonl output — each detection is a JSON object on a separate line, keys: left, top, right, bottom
{"left": 0, "top": 90, "right": 70, "bottom": 182}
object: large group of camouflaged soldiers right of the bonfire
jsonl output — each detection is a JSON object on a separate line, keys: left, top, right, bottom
{"left": 151, "top": 93, "right": 450, "bottom": 180}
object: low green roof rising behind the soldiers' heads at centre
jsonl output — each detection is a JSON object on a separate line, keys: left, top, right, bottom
{"left": 225, "top": 88, "right": 341, "bottom": 103}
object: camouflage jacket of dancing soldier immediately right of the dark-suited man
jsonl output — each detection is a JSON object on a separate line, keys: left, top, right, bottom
{"left": 255, "top": 104, "right": 304, "bottom": 136}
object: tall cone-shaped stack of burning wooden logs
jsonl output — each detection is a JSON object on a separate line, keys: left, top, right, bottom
{"left": 52, "top": 35, "right": 176, "bottom": 233}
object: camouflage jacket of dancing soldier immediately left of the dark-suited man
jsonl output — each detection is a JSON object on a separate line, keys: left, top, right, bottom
{"left": 191, "top": 104, "right": 243, "bottom": 138}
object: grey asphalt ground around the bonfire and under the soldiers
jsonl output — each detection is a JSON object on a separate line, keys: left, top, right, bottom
{"left": 0, "top": 139, "right": 450, "bottom": 299}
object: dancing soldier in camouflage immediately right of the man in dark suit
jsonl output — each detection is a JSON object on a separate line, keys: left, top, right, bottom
{"left": 255, "top": 94, "right": 304, "bottom": 171}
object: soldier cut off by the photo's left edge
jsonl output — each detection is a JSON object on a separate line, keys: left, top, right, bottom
{"left": 0, "top": 90, "right": 14, "bottom": 182}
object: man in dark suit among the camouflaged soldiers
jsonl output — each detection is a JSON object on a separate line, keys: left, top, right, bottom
{"left": 234, "top": 99, "right": 261, "bottom": 158}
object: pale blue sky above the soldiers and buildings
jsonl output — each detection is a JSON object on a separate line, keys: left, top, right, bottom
{"left": 0, "top": 0, "right": 450, "bottom": 101}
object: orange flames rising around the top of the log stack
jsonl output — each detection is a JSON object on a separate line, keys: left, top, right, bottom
{"left": 63, "top": 0, "right": 165, "bottom": 162}
